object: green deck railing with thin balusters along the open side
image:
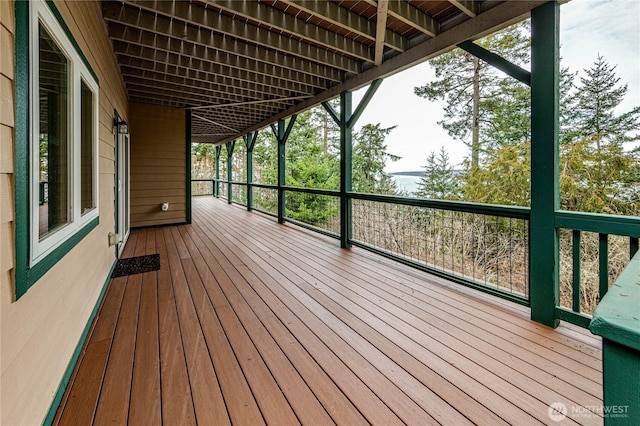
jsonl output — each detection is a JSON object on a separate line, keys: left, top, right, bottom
{"left": 198, "top": 179, "right": 640, "bottom": 327}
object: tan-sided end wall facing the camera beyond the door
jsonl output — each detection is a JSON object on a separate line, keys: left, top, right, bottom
{"left": 129, "top": 104, "right": 187, "bottom": 227}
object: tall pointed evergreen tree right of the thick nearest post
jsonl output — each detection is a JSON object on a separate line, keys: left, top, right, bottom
{"left": 560, "top": 55, "right": 640, "bottom": 215}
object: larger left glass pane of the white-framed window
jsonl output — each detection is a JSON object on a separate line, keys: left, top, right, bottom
{"left": 38, "top": 24, "right": 71, "bottom": 240}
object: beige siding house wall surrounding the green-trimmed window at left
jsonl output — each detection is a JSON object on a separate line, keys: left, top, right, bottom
{"left": 0, "top": 0, "right": 128, "bottom": 425}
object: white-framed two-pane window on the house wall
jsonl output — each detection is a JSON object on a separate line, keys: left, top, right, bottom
{"left": 28, "top": 1, "right": 99, "bottom": 267}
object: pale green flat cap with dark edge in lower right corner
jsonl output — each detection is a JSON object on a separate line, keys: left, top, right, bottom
{"left": 589, "top": 253, "right": 640, "bottom": 351}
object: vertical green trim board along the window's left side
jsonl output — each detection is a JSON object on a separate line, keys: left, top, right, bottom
{"left": 14, "top": 1, "right": 33, "bottom": 299}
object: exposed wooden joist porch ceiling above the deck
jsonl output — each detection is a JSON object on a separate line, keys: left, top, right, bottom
{"left": 103, "top": 0, "right": 544, "bottom": 143}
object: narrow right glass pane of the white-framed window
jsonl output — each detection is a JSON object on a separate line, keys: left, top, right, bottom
{"left": 80, "top": 81, "right": 96, "bottom": 215}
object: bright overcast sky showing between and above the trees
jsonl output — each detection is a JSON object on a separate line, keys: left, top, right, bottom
{"left": 353, "top": 0, "right": 640, "bottom": 172}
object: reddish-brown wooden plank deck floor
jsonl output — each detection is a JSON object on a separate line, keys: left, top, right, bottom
{"left": 56, "top": 197, "right": 602, "bottom": 425}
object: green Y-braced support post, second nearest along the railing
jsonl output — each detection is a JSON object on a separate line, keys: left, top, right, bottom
{"left": 322, "top": 79, "right": 382, "bottom": 248}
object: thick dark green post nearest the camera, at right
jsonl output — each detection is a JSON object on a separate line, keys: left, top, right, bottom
{"left": 529, "top": 1, "right": 560, "bottom": 327}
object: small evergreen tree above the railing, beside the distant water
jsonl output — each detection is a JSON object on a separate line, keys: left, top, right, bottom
{"left": 416, "top": 146, "right": 459, "bottom": 200}
